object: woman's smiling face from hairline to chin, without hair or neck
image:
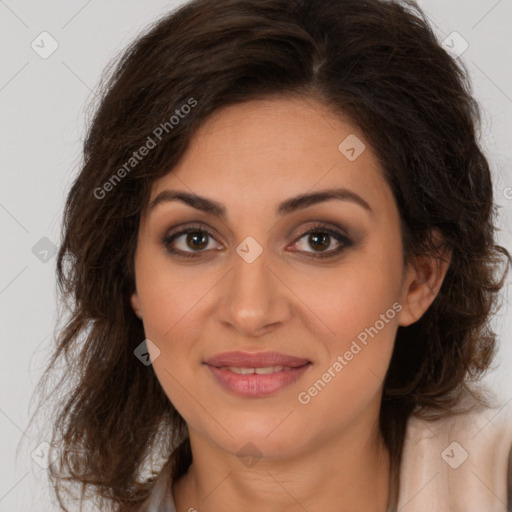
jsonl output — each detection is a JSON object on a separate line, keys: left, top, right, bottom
{"left": 132, "top": 99, "right": 420, "bottom": 458}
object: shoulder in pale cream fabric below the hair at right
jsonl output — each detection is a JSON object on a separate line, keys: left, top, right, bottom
{"left": 398, "top": 394, "right": 512, "bottom": 512}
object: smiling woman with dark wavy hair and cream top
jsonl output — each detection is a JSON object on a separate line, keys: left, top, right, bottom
{"left": 33, "top": 0, "right": 512, "bottom": 512}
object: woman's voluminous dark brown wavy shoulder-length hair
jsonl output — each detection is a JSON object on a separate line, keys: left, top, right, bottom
{"left": 29, "top": 0, "right": 510, "bottom": 511}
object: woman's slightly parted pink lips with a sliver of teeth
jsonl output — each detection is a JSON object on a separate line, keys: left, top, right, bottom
{"left": 203, "top": 352, "right": 312, "bottom": 398}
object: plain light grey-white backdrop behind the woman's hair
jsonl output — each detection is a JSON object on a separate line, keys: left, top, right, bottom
{"left": 0, "top": 0, "right": 512, "bottom": 512}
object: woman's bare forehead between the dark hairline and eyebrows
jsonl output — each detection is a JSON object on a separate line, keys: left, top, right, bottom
{"left": 151, "top": 98, "right": 392, "bottom": 216}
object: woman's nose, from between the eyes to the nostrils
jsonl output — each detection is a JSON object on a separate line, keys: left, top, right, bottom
{"left": 217, "top": 245, "right": 291, "bottom": 338}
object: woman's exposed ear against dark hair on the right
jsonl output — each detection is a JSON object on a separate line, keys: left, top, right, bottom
{"left": 398, "top": 232, "right": 452, "bottom": 327}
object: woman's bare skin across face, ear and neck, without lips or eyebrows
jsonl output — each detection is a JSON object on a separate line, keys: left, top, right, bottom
{"left": 131, "top": 97, "right": 449, "bottom": 512}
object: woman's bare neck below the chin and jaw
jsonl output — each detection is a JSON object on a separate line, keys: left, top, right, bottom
{"left": 173, "top": 414, "right": 391, "bottom": 512}
